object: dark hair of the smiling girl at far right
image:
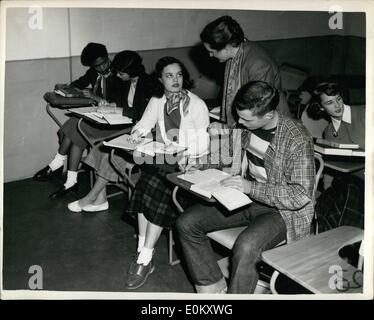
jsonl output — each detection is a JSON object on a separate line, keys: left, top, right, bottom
{"left": 306, "top": 82, "right": 343, "bottom": 120}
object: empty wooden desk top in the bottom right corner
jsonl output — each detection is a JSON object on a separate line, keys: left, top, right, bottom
{"left": 262, "top": 226, "right": 364, "bottom": 293}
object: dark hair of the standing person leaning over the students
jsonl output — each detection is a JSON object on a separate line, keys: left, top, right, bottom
{"left": 200, "top": 16, "right": 244, "bottom": 50}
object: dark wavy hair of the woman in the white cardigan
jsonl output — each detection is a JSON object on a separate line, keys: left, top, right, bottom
{"left": 151, "top": 57, "right": 193, "bottom": 98}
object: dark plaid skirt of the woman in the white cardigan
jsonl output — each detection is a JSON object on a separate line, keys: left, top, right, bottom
{"left": 127, "top": 165, "right": 178, "bottom": 228}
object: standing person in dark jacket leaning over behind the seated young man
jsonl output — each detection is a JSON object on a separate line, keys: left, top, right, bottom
{"left": 200, "top": 16, "right": 290, "bottom": 133}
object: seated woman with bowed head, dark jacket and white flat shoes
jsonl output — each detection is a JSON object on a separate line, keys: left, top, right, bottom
{"left": 68, "top": 51, "right": 151, "bottom": 212}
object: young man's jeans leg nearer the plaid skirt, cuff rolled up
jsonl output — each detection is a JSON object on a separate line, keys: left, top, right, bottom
{"left": 176, "top": 204, "right": 253, "bottom": 293}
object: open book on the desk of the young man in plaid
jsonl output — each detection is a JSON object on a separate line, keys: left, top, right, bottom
{"left": 178, "top": 169, "right": 252, "bottom": 211}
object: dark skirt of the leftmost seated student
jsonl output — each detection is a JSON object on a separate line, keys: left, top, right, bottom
{"left": 59, "top": 116, "right": 123, "bottom": 149}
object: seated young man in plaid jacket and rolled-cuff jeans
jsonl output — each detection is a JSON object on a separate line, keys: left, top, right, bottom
{"left": 177, "top": 81, "right": 315, "bottom": 293}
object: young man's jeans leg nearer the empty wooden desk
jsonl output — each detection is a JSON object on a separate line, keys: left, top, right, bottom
{"left": 228, "top": 203, "right": 287, "bottom": 293}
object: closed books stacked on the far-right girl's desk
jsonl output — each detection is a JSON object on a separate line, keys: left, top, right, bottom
{"left": 314, "top": 139, "right": 365, "bottom": 157}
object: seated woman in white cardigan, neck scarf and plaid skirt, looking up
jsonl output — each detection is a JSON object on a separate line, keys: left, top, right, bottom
{"left": 126, "top": 57, "right": 209, "bottom": 289}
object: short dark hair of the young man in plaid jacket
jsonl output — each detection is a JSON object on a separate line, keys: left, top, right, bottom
{"left": 234, "top": 81, "right": 279, "bottom": 116}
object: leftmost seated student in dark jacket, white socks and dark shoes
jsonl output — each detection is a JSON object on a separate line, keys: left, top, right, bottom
{"left": 34, "top": 42, "right": 118, "bottom": 199}
